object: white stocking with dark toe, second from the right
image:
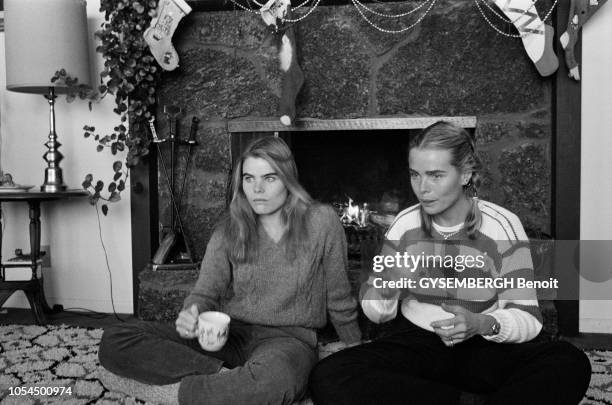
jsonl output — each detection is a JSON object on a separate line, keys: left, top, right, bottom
{"left": 495, "top": 0, "right": 559, "bottom": 76}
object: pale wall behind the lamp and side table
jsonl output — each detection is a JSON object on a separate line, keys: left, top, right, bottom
{"left": 0, "top": 0, "right": 133, "bottom": 313}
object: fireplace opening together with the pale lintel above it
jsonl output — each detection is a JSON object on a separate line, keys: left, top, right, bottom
{"left": 228, "top": 117, "right": 476, "bottom": 215}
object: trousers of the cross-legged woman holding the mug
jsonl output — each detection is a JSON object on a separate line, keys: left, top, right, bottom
{"left": 98, "top": 320, "right": 317, "bottom": 405}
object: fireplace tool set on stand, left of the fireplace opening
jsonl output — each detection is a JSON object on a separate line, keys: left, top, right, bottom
{"left": 149, "top": 106, "right": 200, "bottom": 270}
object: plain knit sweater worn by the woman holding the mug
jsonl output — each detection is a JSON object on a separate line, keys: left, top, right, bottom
{"left": 184, "top": 205, "right": 361, "bottom": 343}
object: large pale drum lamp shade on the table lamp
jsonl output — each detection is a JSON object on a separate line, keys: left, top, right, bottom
{"left": 4, "top": 0, "right": 91, "bottom": 94}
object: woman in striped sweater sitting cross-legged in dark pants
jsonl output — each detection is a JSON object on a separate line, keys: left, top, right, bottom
{"left": 310, "top": 122, "right": 590, "bottom": 405}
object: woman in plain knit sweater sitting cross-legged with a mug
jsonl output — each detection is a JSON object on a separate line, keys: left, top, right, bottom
{"left": 99, "top": 137, "right": 361, "bottom": 404}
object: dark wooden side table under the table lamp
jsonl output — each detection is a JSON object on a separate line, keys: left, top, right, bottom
{"left": 0, "top": 190, "right": 89, "bottom": 325}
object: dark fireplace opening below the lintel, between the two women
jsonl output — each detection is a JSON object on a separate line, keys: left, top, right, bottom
{"left": 287, "top": 130, "right": 415, "bottom": 214}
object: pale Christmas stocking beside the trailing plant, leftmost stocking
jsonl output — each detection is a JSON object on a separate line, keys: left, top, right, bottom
{"left": 144, "top": 0, "right": 191, "bottom": 70}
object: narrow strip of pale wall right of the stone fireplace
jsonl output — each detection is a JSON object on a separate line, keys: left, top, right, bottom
{"left": 580, "top": 4, "right": 612, "bottom": 333}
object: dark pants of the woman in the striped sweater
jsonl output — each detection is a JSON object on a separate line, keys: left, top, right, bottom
{"left": 310, "top": 315, "right": 591, "bottom": 405}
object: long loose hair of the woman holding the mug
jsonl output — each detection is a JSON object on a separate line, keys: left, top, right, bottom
{"left": 224, "top": 136, "right": 313, "bottom": 263}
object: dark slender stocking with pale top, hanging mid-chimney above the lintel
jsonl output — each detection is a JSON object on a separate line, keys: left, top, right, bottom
{"left": 260, "top": 0, "right": 304, "bottom": 126}
